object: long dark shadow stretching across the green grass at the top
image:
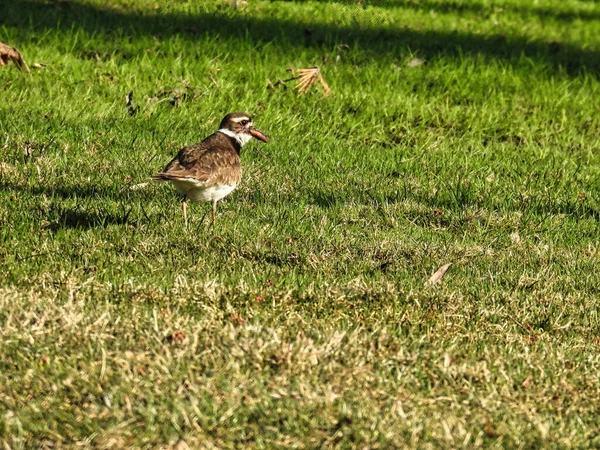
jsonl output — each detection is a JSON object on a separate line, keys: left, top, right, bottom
{"left": 0, "top": 0, "right": 600, "bottom": 75}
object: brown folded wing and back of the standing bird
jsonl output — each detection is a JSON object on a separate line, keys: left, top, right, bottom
{"left": 152, "top": 133, "right": 242, "bottom": 185}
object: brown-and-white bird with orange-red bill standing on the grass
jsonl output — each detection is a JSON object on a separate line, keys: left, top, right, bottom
{"left": 152, "top": 113, "right": 267, "bottom": 227}
